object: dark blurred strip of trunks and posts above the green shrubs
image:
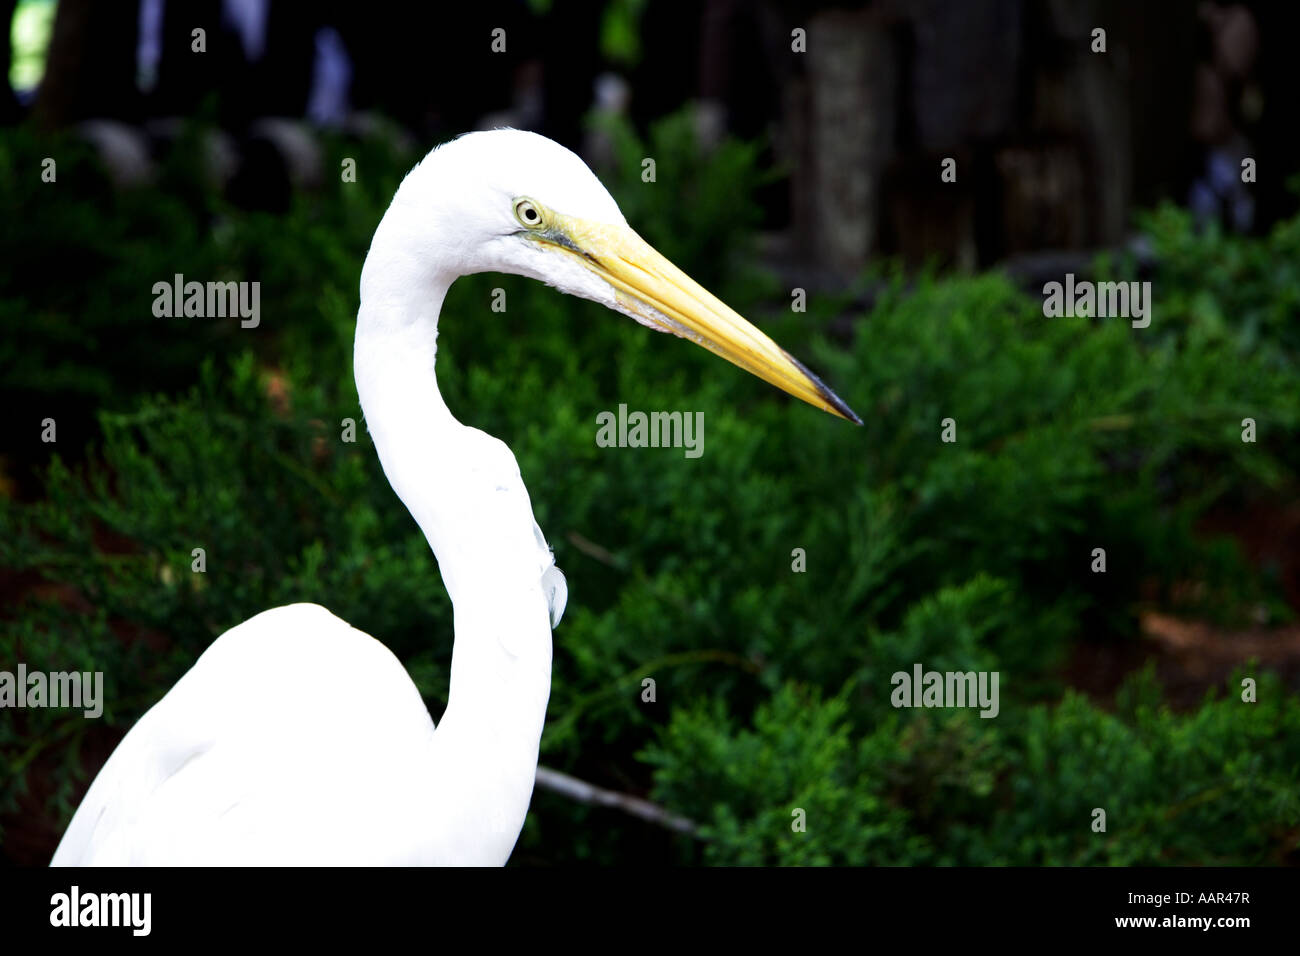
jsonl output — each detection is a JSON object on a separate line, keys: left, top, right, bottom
{"left": 15, "top": 0, "right": 1300, "bottom": 281}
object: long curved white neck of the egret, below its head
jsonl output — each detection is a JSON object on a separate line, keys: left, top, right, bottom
{"left": 354, "top": 213, "right": 551, "bottom": 862}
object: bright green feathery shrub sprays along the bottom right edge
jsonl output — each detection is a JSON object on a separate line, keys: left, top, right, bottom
{"left": 642, "top": 670, "right": 1300, "bottom": 866}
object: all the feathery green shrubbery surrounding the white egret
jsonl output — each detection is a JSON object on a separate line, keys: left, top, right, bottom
{"left": 0, "top": 116, "right": 1300, "bottom": 864}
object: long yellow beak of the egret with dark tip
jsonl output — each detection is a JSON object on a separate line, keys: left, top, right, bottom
{"left": 537, "top": 216, "right": 862, "bottom": 425}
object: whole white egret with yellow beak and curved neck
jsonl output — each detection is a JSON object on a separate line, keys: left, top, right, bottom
{"left": 53, "top": 130, "right": 857, "bottom": 865}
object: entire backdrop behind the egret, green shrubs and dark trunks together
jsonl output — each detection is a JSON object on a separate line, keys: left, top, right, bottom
{"left": 0, "top": 0, "right": 1300, "bottom": 865}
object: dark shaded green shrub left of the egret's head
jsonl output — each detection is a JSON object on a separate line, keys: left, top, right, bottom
{"left": 0, "top": 127, "right": 404, "bottom": 446}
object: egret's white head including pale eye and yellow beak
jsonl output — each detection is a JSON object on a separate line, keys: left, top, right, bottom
{"left": 382, "top": 130, "right": 862, "bottom": 424}
